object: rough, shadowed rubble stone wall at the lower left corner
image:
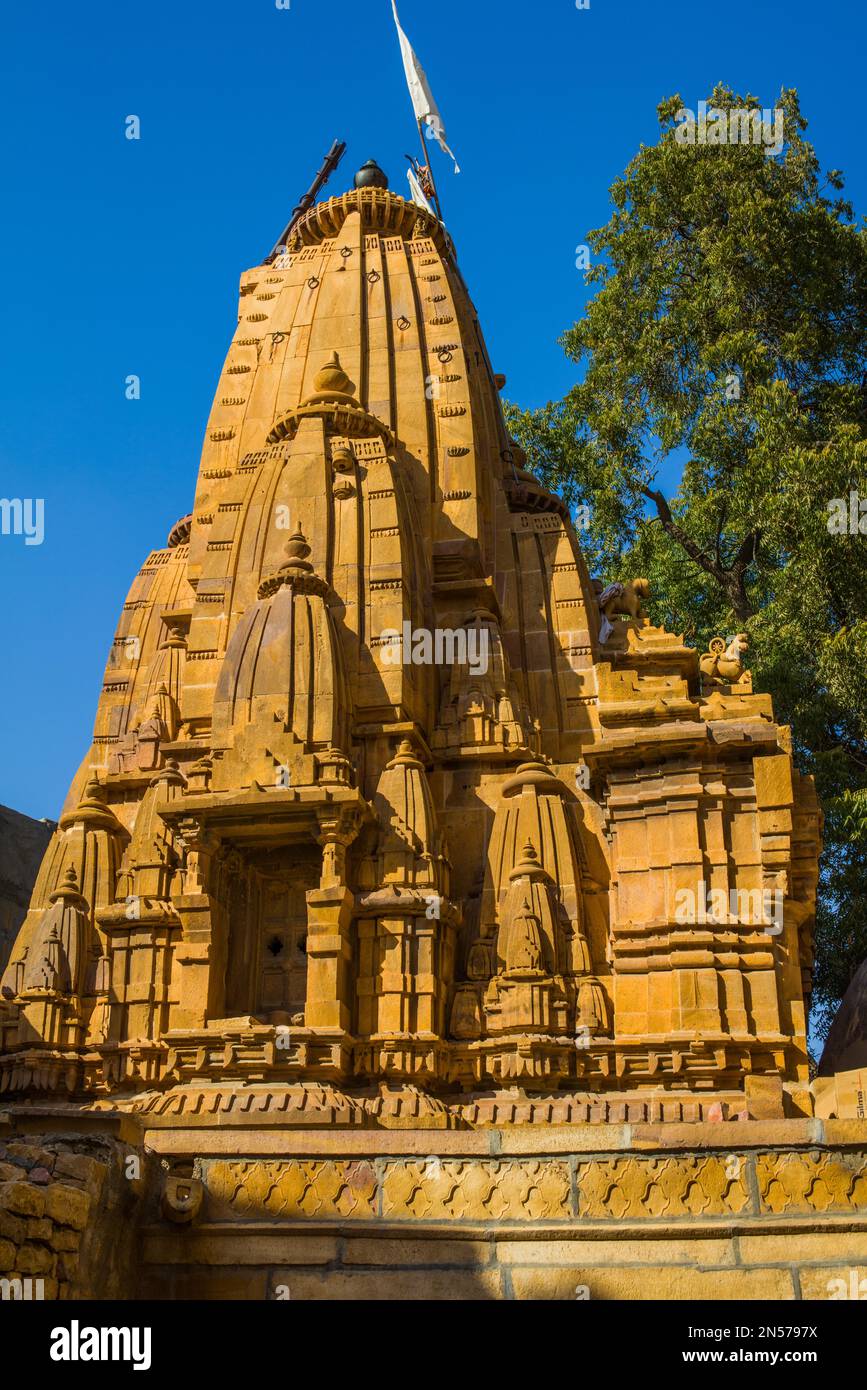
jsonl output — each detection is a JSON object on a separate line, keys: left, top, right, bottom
{"left": 0, "top": 1118, "right": 142, "bottom": 1300}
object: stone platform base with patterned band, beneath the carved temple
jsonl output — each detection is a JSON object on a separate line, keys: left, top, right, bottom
{"left": 7, "top": 1108, "right": 867, "bottom": 1300}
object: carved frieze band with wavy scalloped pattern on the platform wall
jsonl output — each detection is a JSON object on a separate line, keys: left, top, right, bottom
{"left": 203, "top": 1150, "right": 867, "bottom": 1222}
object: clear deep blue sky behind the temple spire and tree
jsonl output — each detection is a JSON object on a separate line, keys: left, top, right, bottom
{"left": 0, "top": 0, "right": 867, "bottom": 817}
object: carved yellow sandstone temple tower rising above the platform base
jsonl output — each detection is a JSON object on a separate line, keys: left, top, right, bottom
{"left": 0, "top": 170, "right": 844, "bottom": 1301}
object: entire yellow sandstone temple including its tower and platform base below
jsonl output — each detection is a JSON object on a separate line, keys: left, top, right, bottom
{"left": 0, "top": 165, "right": 867, "bottom": 1300}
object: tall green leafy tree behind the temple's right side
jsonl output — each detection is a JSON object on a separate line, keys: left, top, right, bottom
{"left": 509, "top": 86, "right": 867, "bottom": 1034}
